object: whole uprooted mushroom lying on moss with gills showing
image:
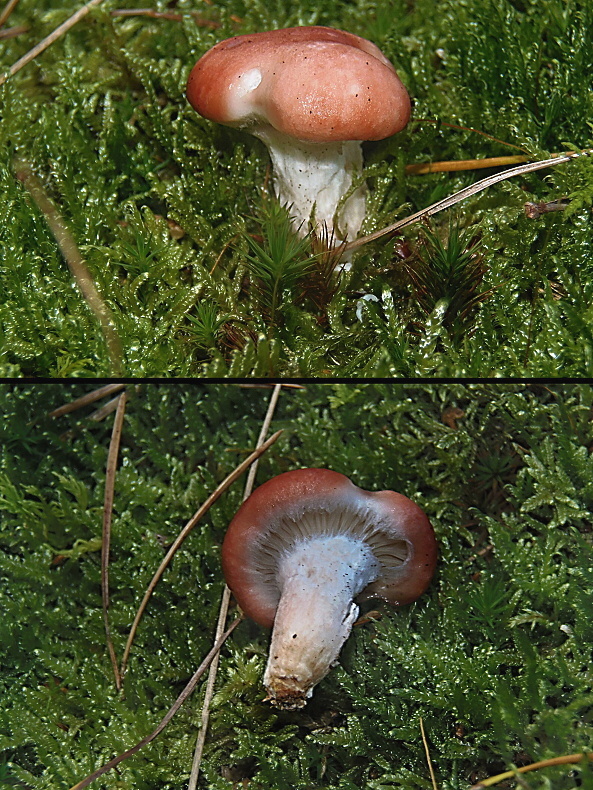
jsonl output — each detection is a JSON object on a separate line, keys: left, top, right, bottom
{"left": 222, "top": 469, "right": 436, "bottom": 710}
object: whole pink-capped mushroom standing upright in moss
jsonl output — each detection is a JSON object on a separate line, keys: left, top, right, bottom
{"left": 187, "top": 26, "right": 410, "bottom": 240}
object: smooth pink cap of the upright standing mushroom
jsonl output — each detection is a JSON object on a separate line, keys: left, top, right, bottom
{"left": 187, "top": 26, "right": 410, "bottom": 142}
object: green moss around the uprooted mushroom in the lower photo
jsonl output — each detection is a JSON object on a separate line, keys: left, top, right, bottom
{"left": 0, "top": 383, "right": 593, "bottom": 790}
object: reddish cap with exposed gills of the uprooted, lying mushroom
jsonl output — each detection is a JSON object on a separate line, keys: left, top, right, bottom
{"left": 222, "top": 469, "right": 437, "bottom": 627}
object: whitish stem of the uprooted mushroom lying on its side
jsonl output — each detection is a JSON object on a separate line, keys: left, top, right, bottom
{"left": 264, "top": 535, "right": 379, "bottom": 708}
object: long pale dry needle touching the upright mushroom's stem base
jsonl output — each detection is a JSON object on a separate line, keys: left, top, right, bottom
{"left": 344, "top": 149, "right": 593, "bottom": 253}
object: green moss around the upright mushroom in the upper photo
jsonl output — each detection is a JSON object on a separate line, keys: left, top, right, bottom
{"left": 0, "top": 0, "right": 593, "bottom": 377}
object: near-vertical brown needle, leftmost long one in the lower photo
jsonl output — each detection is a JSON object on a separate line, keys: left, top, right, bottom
{"left": 101, "top": 391, "right": 126, "bottom": 691}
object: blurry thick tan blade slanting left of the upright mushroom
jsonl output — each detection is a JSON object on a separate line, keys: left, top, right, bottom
{"left": 14, "top": 160, "right": 122, "bottom": 376}
